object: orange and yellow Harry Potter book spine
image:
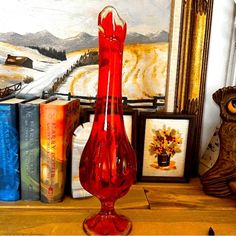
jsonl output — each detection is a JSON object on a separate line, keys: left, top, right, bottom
{"left": 40, "top": 104, "right": 66, "bottom": 203}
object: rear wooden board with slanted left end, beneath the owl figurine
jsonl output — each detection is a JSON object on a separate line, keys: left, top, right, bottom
{"left": 144, "top": 179, "right": 236, "bottom": 210}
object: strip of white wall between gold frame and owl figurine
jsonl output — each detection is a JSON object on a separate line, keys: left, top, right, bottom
{"left": 200, "top": 0, "right": 234, "bottom": 159}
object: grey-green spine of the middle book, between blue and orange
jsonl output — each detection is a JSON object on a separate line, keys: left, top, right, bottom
{"left": 19, "top": 104, "right": 40, "bottom": 200}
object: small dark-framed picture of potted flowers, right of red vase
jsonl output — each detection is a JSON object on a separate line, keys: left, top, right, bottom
{"left": 138, "top": 112, "right": 194, "bottom": 182}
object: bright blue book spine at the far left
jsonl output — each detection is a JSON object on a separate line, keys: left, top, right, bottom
{"left": 0, "top": 104, "right": 20, "bottom": 201}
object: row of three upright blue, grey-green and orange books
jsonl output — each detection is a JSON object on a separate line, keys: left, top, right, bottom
{"left": 0, "top": 98, "right": 80, "bottom": 203}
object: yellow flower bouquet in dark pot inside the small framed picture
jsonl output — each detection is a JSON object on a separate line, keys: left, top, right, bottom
{"left": 149, "top": 125, "right": 183, "bottom": 170}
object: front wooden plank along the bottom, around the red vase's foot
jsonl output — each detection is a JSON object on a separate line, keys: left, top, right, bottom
{"left": 0, "top": 209, "right": 236, "bottom": 235}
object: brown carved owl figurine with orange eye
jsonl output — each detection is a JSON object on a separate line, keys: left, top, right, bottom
{"left": 200, "top": 86, "right": 236, "bottom": 197}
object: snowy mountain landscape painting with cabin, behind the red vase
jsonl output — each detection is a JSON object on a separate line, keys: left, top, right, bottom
{"left": 0, "top": 0, "right": 171, "bottom": 99}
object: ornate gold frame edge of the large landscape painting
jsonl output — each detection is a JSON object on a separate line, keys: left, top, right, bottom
{"left": 174, "top": 0, "right": 213, "bottom": 173}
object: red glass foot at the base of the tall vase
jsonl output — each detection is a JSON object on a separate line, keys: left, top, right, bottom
{"left": 83, "top": 213, "right": 132, "bottom": 235}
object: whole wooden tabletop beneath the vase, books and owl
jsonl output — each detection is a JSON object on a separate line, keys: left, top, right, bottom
{"left": 0, "top": 179, "right": 236, "bottom": 235}
